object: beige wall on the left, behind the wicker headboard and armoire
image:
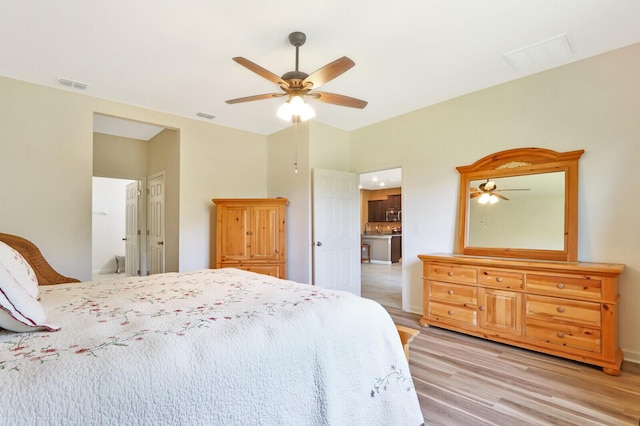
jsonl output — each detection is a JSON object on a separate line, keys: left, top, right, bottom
{"left": 0, "top": 77, "right": 267, "bottom": 280}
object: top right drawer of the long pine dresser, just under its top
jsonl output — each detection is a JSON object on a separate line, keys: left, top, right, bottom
{"left": 526, "top": 274, "right": 602, "bottom": 300}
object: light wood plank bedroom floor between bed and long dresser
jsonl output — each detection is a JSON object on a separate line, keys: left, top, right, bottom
{"left": 386, "top": 307, "right": 640, "bottom": 426}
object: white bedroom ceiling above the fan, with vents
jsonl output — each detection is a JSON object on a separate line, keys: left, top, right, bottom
{"left": 0, "top": 0, "right": 640, "bottom": 134}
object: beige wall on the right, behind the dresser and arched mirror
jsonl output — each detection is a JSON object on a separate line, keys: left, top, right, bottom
{"left": 351, "top": 44, "right": 640, "bottom": 362}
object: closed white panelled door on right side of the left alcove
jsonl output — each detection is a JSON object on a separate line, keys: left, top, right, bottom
{"left": 147, "top": 172, "right": 165, "bottom": 274}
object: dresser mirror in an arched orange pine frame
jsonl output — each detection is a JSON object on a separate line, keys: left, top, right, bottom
{"left": 456, "top": 148, "right": 584, "bottom": 261}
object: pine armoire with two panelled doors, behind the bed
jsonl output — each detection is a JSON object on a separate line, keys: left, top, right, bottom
{"left": 211, "top": 198, "right": 289, "bottom": 278}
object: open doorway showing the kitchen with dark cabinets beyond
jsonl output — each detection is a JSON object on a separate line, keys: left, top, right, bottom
{"left": 360, "top": 168, "right": 403, "bottom": 309}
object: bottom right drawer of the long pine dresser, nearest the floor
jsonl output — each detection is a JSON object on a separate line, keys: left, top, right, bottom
{"left": 525, "top": 321, "right": 602, "bottom": 353}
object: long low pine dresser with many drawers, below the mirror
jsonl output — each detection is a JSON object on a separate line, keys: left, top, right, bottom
{"left": 418, "top": 254, "right": 624, "bottom": 375}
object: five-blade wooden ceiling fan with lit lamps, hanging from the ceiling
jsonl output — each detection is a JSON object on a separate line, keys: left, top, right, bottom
{"left": 226, "top": 31, "right": 367, "bottom": 123}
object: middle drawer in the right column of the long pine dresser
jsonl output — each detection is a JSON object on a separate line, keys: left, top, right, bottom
{"left": 525, "top": 295, "right": 602, "bottom": 327}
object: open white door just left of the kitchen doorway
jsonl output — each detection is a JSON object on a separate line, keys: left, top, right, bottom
{"left": 312, "top": 169, "right": 360, "bottom": 296}
